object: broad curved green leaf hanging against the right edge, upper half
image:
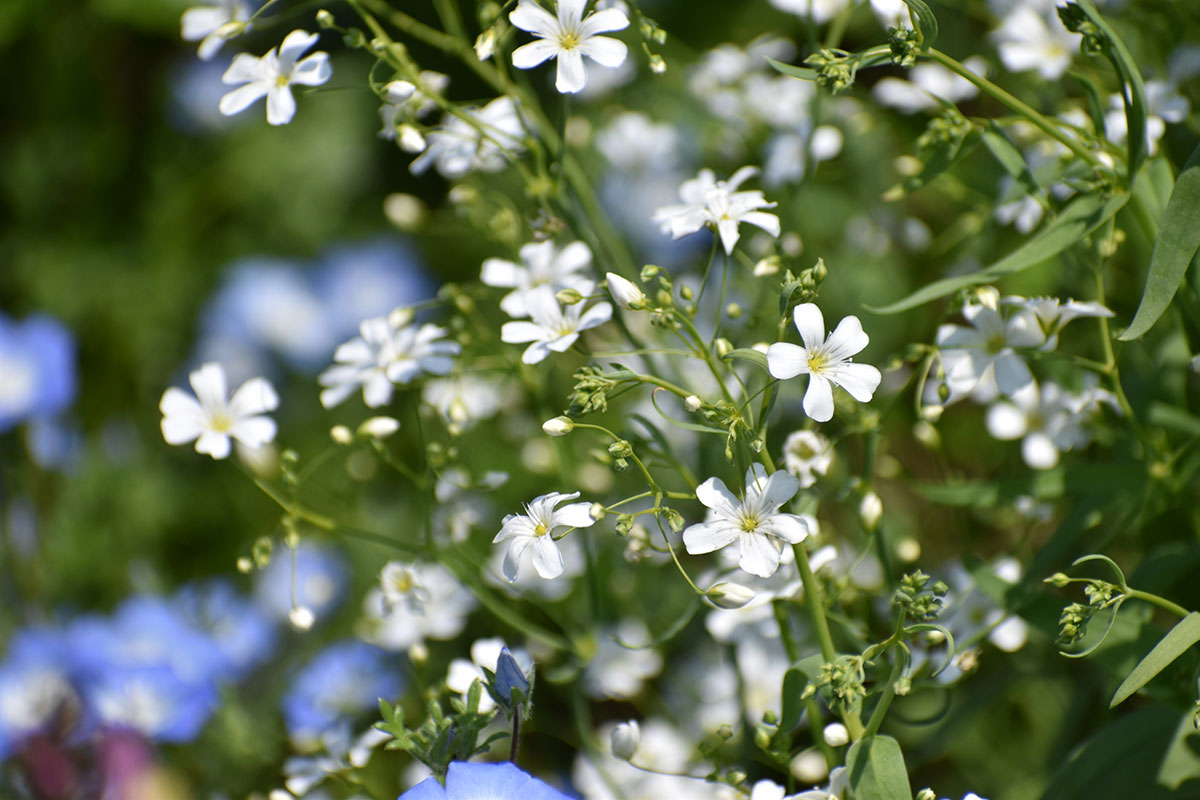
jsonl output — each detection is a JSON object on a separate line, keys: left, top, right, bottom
{"left": 1118, "top": 145, "right": 1200, "bottom": 342}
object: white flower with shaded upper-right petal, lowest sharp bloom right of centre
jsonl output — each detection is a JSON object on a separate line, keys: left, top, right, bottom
{"left": 683, "top": 464, "right": 811, "bottom": 578}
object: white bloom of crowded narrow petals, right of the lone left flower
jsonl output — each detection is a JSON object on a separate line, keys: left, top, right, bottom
{"left": 317, "top": 313, "right": 461, "bottom": 408}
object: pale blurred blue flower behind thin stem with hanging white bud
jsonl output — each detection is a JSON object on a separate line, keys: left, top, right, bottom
{"left": 254, "top": 542, "right": 347, "bottom": 620}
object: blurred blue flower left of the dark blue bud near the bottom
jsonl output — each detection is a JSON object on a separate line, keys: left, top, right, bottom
{"left": 283, "top": 639, "right": 404, "bottom": 742}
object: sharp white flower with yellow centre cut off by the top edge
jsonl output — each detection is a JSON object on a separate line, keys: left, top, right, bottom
{"left": 509, "top": 0, "right": 629, "bottom": 94}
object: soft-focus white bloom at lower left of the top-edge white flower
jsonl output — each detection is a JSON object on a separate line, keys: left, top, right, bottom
{"left": 409, "top": 96, "right": 524, "bottom": 178}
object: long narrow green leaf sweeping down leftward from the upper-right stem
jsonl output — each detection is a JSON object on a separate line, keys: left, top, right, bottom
{"left": 866, "top": 192, "right": 1129, "bottom": 314}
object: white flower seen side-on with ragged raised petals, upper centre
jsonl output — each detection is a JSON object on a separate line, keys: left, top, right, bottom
{"left": 653, "top": 167, "right": 780, "bottom": 254}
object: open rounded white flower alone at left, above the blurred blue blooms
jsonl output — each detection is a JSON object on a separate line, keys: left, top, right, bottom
{"left": 158, "top": 363, "right": 280, "bottom": 458}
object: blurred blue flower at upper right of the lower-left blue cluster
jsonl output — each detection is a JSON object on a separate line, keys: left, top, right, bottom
{"left": 174, "top": 579, "right": 278, "bottom": 678}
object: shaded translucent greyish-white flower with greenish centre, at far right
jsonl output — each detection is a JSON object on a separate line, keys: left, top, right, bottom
{"left": 937, "top": 303, "right": 1045, "bottom": 398}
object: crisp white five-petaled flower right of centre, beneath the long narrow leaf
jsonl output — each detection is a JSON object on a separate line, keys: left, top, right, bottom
{"left": 767, "top": 302, "right": 883, "bottom": 422}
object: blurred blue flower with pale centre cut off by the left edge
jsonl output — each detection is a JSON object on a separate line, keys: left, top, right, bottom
{"left": 0, "top": 314, "right": 76, "bottom": 432}
